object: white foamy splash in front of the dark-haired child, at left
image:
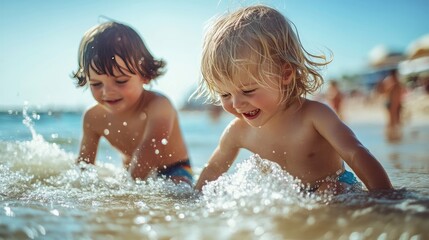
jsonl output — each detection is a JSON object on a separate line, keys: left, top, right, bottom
{"left": 0, "top": 103, "right": 194, "bottom": 202}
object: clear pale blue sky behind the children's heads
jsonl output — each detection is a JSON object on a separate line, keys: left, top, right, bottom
{"left": 0, "top": 0, "right": 429, "bottom": 109}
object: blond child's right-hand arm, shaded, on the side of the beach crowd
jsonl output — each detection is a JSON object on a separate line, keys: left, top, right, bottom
{"left": 312, "top": 103, "right": 392, "bottom": 190}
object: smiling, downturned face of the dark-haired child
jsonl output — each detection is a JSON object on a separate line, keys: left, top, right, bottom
{"left": 89, "top": 56, "right": 145, "bottom": 113}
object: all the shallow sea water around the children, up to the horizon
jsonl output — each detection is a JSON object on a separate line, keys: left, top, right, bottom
{"left": 0, "top": 109, "right": 429, "bottom": 239}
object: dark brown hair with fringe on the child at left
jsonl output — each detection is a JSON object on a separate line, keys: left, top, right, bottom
{"left": 73, "top": 22, "right": 165, "bottom": 87}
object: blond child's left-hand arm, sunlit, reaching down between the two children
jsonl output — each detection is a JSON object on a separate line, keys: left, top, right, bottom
{"left": 195, "top": 122, "right": 240, "bottom": 191}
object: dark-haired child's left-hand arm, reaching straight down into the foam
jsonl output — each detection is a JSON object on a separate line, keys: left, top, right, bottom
{"left": 76, "top": 111, "right": 100, "bottom": 164}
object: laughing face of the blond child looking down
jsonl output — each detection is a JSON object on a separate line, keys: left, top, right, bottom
{"left": 219, "top": 67, "right": 283, "bottom": 127}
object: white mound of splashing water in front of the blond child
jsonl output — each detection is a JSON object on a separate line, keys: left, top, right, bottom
{"left": 202, "top": 155, "right": 329, "bottom": 216}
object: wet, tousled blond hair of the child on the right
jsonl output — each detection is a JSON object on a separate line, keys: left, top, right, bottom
{"left": 197, "top": 5, "right": 330, "bottom": 105}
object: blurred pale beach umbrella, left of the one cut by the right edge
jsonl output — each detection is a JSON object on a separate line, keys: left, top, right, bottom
{"left": 369, "top": 45, "right": 405, "bottom": 69}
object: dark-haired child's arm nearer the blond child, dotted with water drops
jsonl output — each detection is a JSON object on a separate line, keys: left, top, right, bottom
{"left": 129, "top": 98, "right": 177, "bottom": 180}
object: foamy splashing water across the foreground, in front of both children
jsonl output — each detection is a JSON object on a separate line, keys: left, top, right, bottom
{"left": 0, "top": 109, "right": 428, "bottom": 239}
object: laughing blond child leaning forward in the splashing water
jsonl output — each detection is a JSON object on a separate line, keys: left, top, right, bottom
{"left": 196, "top": 5, "right": 392, "bottom": 193}
